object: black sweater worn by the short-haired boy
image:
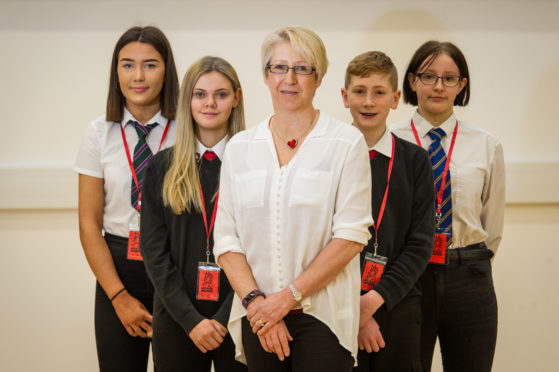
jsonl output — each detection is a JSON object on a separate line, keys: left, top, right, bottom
{"left": 361, "top": 136, "right": 435, "bottom": 310}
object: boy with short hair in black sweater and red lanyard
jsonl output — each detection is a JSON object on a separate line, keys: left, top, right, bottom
{"left": 342, "top": 52, "right": 435, "bottom": 371}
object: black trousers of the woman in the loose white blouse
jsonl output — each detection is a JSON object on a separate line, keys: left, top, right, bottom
{"left": 242, "top": 313, "right": 353, "bottom": 372}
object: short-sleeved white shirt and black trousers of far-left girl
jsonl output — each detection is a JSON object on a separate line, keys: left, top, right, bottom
{"left": 74, "top": 108, "right": 175, "bottom": 372}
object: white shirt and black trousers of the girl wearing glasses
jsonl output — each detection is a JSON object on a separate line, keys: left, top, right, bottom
{"left": 391, "top": 112, "right": 505, "bottom": 371}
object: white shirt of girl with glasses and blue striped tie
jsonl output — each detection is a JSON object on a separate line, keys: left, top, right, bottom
{"left": 390, "top": 112, "right": 505, "bottom": 252}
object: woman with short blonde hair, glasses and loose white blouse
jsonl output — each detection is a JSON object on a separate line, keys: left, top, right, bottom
{"left": 214, "top": 27, "right": 372, "bottom": 372}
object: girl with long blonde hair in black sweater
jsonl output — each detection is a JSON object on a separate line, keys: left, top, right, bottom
{"left": 140, "top": 57, "right": 246, "bottom": 372}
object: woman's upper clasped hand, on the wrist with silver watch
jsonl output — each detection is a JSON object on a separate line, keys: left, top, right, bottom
{"left": 247, "top": 288, "right": 295, "bottom": 335}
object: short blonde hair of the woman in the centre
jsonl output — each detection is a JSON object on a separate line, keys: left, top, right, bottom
{"left": 262, "top": 26, "right": 328, "bottom": 81}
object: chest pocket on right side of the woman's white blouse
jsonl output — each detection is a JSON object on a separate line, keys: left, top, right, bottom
{"left": 289, "top": 169, "right": 332, "bottom": 209}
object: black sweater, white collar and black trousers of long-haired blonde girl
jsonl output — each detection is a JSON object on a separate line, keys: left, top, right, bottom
{"left": 140, "top": 138, "right": 246, "bottom": 372}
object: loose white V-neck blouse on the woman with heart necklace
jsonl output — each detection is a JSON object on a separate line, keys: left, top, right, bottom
{"left": 217, "top": 113, "right": 373, "bottom": 361}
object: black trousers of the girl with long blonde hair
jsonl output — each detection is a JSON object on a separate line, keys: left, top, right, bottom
{"left": 153, "top": 322, "right": 247, "bottom": 372}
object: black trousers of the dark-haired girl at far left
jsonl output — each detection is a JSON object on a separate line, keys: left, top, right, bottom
{"left": 95, "top": 234, "right": 153, "bottom": 372}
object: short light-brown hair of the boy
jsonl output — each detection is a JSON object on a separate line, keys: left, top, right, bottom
{"left": 345, "top": 51, "right": 398, "bottom": 92}
